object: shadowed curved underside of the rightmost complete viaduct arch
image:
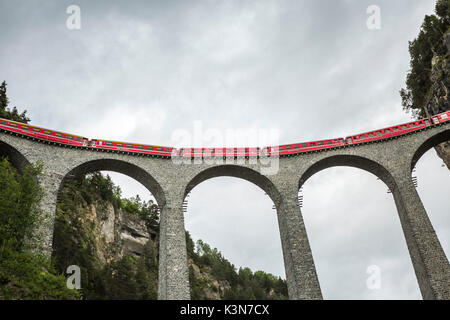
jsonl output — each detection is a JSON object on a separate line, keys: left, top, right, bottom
{"left": 298, "top": 155, "right": 396, "bottom": 190}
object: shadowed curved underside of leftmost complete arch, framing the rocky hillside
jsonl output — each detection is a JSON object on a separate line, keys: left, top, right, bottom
{"left": 58, "top": 159, "right": 166, "bottom": 207}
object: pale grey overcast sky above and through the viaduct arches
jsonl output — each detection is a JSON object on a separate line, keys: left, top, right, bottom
{"left": 0, "top": 0, "right": 450, "bottom": 299}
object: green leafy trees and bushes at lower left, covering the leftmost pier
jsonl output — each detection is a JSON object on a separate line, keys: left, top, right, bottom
{"left": 0, "top": 158, "right": 79, "bottom": 299}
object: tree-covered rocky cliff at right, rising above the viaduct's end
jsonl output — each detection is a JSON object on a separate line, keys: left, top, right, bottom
{"left": 400, "top": 0, "right": 450, "bottom": 169}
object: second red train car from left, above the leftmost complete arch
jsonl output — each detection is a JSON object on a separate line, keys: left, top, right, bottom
{"left": 89, "top": 139, "right": 173, "bottom": 156}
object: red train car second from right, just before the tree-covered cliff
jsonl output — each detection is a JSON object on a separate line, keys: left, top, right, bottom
{"left": 345, "top": 119, "right": 431, "bottom": 144}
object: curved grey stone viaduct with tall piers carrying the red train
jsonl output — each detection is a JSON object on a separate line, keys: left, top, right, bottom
{"left": 0, "top": 123, "right": 450, "bottom": 299}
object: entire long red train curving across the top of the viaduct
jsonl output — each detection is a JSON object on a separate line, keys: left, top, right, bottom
{"left": 0, "top": 111, "right": 450, "bottom": 158}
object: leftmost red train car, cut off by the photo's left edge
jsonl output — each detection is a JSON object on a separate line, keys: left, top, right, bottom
{"left": 0, "top": 119, "right": 89, "bottom": 146}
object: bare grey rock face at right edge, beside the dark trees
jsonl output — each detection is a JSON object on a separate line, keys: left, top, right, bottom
{"left": 426, "top": 32, "right": 450, "bottom": 170}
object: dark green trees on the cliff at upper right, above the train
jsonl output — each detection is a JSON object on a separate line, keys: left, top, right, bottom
{"left": 400, "top": 0, "right": 450, "bottom": 117}
